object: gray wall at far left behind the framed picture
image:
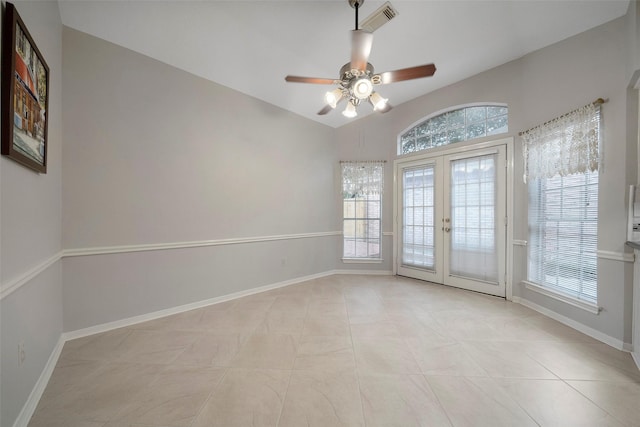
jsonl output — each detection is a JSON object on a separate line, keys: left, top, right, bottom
{"left": 0, "top": 1, "right": 63, "bottom": 426}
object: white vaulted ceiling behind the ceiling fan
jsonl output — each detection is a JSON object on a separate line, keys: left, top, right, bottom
{"left": 59, "top": 0, "right": 629, "bottom": 127}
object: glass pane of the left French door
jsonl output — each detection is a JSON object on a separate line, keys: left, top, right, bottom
{"left": 402, "top": 165, "right": 436, "bottom": 270}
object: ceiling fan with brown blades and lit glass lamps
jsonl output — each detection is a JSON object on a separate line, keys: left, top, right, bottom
{"left": 285, "top": 0, "right": 436, "bottom": 117}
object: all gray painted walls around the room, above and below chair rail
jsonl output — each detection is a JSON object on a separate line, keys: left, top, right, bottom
{"left": 0, "top": 1, "right": 640, "bottom": 426}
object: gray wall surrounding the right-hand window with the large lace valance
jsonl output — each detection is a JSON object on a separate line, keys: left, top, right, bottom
{"left": 522, "top": 18, "right": 637, "bottom": 343}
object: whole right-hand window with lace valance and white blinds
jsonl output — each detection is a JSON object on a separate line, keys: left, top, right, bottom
{"left": 522, "top": 104, "right": 601, "bottom": 306}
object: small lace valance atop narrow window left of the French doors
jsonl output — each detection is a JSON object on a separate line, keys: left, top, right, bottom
{"left": 340, "top": 160, "right": 385, "bottom": 198}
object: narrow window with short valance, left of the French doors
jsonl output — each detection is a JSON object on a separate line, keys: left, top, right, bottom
{"left": 341, "top": 161, "right": 384, "bottom": 260}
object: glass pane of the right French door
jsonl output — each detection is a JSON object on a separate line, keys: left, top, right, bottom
{"left": 449, "top": 154, "right": 498, "bottom": 283}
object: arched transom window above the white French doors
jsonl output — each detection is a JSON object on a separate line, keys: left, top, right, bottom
{"left": 398, "top": 104, "right": 509, "bottom": 154}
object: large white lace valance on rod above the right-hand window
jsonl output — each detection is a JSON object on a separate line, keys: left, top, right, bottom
{"left": 521, "top": 103, "right": 602, "bottom": 182}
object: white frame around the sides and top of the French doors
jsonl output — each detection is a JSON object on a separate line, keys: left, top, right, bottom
{"left": 392, "top": 137, "right": 514, "bottom": 301}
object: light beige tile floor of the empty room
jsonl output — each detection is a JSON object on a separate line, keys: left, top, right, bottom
{"left": 29, "top": 275, "right": 640, "bottom": 427}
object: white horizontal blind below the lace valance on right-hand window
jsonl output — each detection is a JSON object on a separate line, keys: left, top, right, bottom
{"left": 528, "top": 167, "right": 598, "bottom": 303}
